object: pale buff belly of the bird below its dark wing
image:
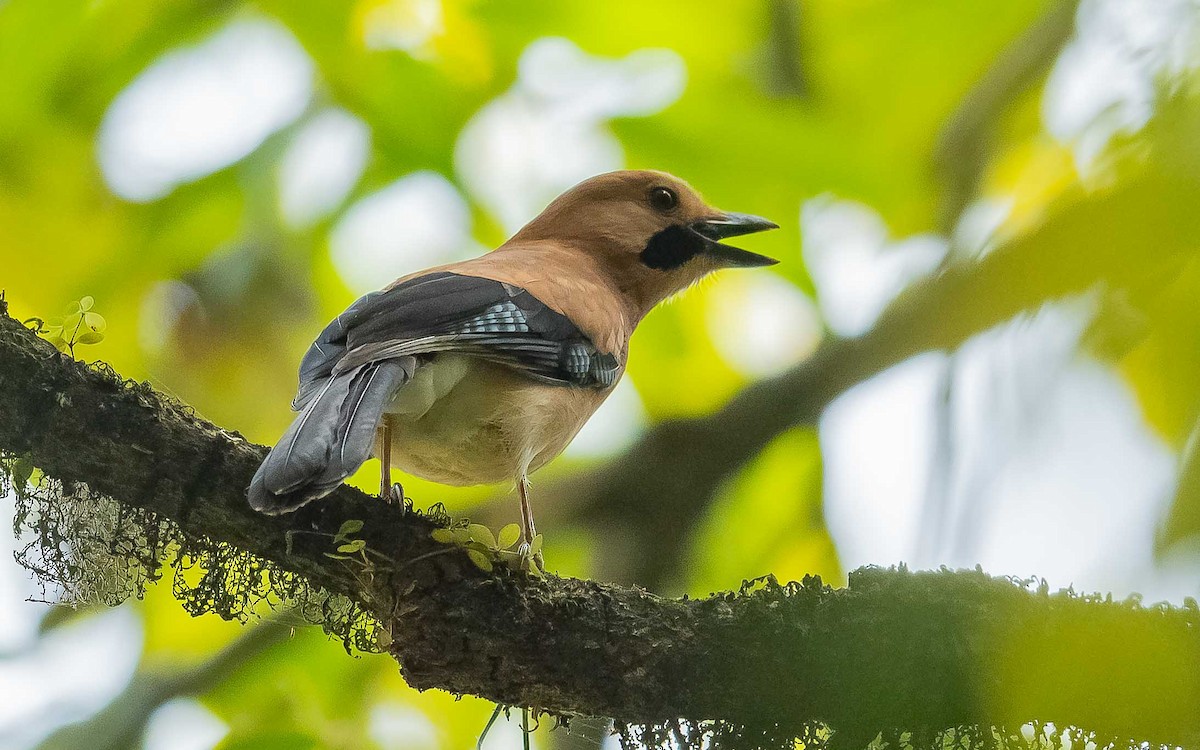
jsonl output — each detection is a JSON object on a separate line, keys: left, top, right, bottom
{"left": 386, "top": 354, "right": 606, "bottom": 486}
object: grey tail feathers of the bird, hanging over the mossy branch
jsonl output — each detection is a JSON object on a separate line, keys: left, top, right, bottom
{"left": 248, "top": 356, "right": 416, "bottom": 515}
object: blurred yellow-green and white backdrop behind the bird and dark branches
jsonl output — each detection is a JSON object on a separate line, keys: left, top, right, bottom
{"left": 0, "top": 0, "right": 1200, "bottom": 750}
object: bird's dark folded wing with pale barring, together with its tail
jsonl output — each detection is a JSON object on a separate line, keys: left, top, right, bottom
{"left": 248, "top": 271, "right": 620, "bottom": 514}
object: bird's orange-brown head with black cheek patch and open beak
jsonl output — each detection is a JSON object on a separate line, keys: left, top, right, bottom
{"left": 511, "top": 170, "right": 778, "bottom": 312}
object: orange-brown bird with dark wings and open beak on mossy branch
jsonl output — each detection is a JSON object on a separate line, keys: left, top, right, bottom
{"left": 247, "top": 170, "right": 778, "bottom": 548}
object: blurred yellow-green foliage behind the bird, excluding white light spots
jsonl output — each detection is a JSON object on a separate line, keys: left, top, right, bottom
{"left": 7, "top": 0, "right": 1200, "bottom": 750}
